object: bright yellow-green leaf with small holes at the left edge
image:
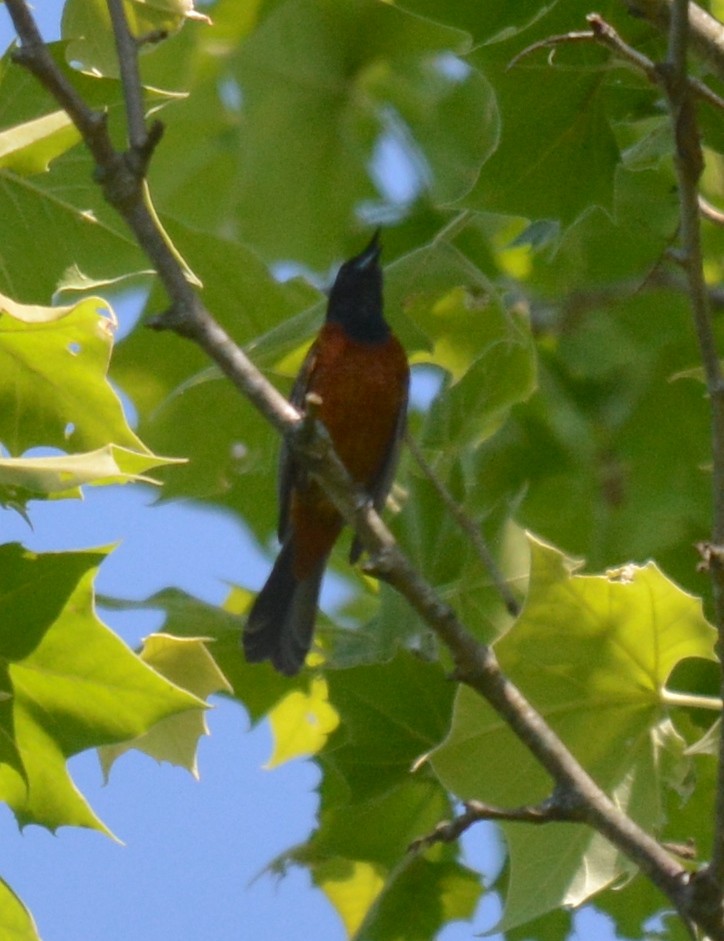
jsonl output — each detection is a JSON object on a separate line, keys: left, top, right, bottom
{"left": 0, "top": 296, "right": 146, "bottom": 454}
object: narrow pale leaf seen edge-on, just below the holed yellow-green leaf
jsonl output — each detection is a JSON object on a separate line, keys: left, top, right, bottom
{"left": 0, "top": 444, "right": 183, "bottom": 505}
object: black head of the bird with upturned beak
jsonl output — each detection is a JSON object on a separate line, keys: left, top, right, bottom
{"left": 327, "top": 229, "right": 390, "bottom": 343}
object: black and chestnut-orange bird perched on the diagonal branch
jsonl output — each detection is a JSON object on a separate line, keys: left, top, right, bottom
{"left": 243, "top": 230, "right": 410, "bottom": 676}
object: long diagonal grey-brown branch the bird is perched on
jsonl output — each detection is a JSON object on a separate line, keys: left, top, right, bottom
{"left": 6, "top": 0, "right": 724, "bottom": 941}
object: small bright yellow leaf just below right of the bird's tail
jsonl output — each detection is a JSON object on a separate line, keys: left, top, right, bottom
{"left": 267, "top": 676, "right": 339, "bottom": 768}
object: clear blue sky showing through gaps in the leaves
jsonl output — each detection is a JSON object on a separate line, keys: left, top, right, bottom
{"left": 0, "top": 7, "right": 616, "bottom": 941}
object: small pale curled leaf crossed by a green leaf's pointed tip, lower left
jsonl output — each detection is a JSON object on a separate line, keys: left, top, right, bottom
{"left": 99, "top": 634, "right": 231, "bottom": 779}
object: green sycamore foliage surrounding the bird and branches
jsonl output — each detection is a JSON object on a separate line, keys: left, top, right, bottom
{"left": 0, "top": 0, "right": 724, "bottom": 941}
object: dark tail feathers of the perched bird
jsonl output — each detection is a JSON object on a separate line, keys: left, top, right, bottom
{"left": 244, "top": 539, "right": 327, "bottom": 676}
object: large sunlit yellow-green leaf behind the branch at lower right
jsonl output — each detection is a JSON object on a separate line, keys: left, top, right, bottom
{"left": 432, "top": 537, "right": 714, "bottom": 927}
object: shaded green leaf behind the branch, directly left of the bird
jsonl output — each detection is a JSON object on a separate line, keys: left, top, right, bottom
{"left": 111, "top": 218, "right": 319, "bottom": 520}
